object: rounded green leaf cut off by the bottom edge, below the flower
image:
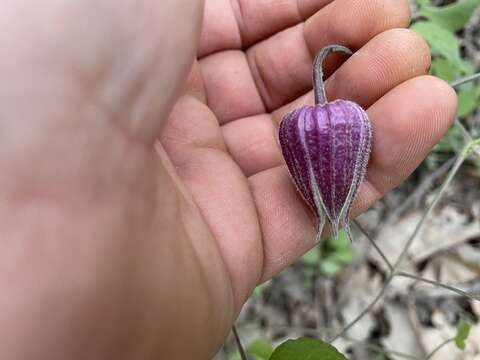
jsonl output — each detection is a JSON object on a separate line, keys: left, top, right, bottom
{"left": 270, "top": 338, "right": 347, "bottom": 360}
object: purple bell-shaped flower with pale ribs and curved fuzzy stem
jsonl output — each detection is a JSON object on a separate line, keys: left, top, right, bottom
{"left": 279, "top": 45, "right": 372, "bottom": 241}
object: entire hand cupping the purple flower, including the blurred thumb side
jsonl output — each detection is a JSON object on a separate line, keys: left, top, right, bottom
{"left": 0, "top": 0, "right": 456, "bottom": 360}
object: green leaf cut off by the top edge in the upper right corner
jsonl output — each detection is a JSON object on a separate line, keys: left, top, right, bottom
{"left": 418, "top": 0, "right": 480, "bottom": 32}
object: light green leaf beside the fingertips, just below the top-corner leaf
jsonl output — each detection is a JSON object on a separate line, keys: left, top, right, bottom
{"left": 410, "top": 21, "right": 472, "bottom": 74}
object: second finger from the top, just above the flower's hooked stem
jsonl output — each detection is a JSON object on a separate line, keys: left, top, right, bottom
{"left": 200, "top": 0, "right": 410, "bottom": 124}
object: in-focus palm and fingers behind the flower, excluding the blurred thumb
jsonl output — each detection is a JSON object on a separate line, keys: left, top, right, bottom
{"left": 161, "top": 0, "right": 455, "bottom": 306}
